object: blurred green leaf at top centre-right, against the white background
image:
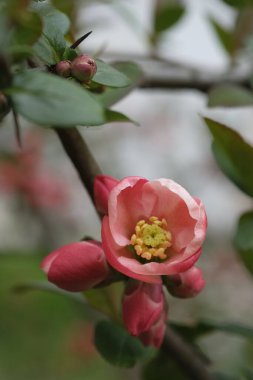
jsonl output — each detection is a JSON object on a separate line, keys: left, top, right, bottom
{"left": 154, "top": 4, "right": 185, "bottom": 34}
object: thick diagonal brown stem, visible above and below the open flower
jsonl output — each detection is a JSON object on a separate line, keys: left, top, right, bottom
{"left": 55, "top": 128, "right": 212, "bottom": 380}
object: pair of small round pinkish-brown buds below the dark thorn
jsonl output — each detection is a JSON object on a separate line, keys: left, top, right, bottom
{"left": 55, "top": 54, "right": 97, "bottom": 84}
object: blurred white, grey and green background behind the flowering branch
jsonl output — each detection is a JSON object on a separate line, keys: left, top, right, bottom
{"left": 0, "top": 0, "right": 253, "bottom": 380}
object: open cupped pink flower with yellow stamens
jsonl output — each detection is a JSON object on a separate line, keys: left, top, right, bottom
{"left": 102, "top": 177, "right": 207, "bottom": 283}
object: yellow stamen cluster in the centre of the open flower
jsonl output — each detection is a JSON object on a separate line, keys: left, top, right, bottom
{"left": 131, "top": 216, "right": 172, "bottom": 261}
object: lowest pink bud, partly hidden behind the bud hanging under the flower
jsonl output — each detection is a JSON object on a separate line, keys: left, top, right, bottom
{"left": 139, "top": 310, "right": 167, "bottom": 348}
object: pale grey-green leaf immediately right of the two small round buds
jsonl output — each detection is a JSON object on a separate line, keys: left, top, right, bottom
{"left": 92, "top": 59, "right": 131, "bottom": 87}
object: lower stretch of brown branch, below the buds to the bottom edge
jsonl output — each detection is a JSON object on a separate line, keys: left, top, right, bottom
{"left": 162, "top": 327, "right": 213, "bottom": 380}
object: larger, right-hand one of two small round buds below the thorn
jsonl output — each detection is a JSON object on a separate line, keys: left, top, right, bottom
{"left": 71, "top": 54, "right": 97, "bottom": 83}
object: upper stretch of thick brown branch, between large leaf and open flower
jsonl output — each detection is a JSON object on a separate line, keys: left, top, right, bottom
{"left": 55, "top": 128, "right": 101, "bottom": 202}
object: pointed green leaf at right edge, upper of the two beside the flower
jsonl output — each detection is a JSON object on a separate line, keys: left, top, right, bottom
{"left": 204, "top": 118, "right": 253, "bottom": 197}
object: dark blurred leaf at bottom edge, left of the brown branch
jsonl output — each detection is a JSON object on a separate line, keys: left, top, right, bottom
{"left": 142, "top": 351, "right": 185, "bottom": 380}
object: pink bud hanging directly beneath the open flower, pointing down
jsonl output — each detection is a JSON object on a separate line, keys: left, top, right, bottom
{"left": 122, "top": 280, "right": 164, "bottom": 335}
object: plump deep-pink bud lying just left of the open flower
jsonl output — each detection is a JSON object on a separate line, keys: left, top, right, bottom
{"left": 41, "top": 241, "right": 110, "bottom": 292}
